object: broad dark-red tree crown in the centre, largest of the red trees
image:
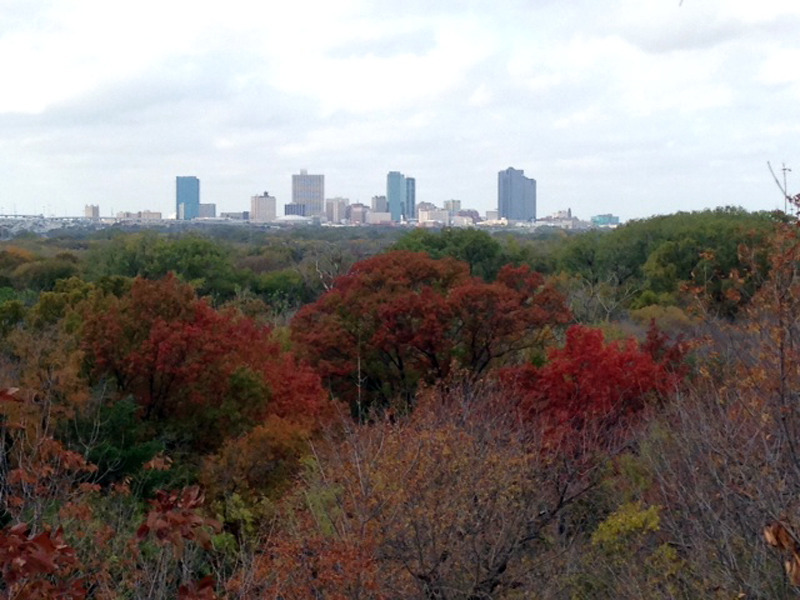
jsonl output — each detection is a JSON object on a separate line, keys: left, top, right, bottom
{"left": 292, "top": 251, "right": 569, "bottom": 410}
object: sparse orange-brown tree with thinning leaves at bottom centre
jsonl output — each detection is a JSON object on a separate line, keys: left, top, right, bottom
{"left": 229, "top": 378, "right": 620, "bottom": 600}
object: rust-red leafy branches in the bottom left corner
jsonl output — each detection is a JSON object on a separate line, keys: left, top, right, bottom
{"left": 0, "top": 388, "right": 225, "bottom": 600}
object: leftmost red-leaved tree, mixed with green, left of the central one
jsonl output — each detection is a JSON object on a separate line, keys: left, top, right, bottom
{"left": 83, "top": 276, "right": 328, "bottom": 450}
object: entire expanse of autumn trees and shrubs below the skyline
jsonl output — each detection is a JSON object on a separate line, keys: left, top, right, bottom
{"left": 0, "top": 209, "right": 800, "bottom": 600}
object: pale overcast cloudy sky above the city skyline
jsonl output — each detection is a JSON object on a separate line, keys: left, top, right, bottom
{"left": 0, "top": 0, "right": 800, "bottom": 219}
